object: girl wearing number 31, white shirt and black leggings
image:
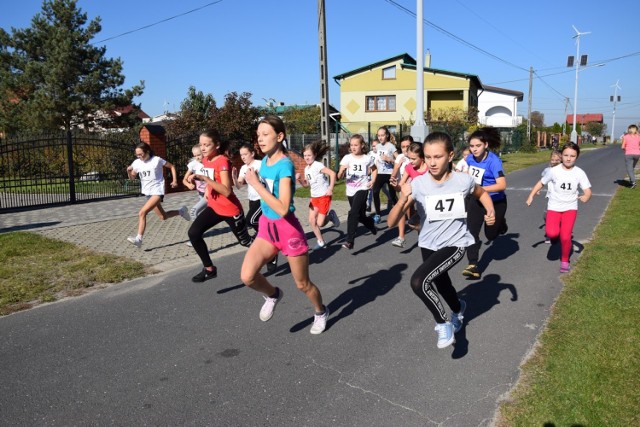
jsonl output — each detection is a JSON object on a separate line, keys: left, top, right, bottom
{"left": 338, "top": 134, "right": 378, "bottom": 249}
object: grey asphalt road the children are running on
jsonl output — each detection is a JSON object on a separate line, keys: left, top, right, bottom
{"left": 0, "top": 146, "right": 637, "bottom": 426}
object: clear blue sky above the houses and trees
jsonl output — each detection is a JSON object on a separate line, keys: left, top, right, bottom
{"left": 0, "top": 0, "right": 640, "bottom": 136}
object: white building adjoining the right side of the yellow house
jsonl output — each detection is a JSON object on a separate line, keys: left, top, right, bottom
{"left": 478, "top": 85, "right": 524, "bottom": 128}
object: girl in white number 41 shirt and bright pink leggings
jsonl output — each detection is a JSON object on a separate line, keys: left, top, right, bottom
{"left": 527, "top": 142, "right": 591, "bottom": 273}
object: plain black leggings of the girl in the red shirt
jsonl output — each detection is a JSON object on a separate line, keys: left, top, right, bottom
{"left": 188, "top": 206, "right": 251, "bottom": 267}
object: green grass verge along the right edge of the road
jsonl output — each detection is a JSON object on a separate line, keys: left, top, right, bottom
{"left": 497, "top": 189, "right": 640, "bottom": 426}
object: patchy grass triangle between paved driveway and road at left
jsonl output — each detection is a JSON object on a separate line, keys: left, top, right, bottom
{"left": 0, "top": 232, "right": 149, "bottom": 315}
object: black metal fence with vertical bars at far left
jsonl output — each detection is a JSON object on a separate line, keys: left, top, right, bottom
{"left": 0, "top": 132, "right": 140, "bottom": 212}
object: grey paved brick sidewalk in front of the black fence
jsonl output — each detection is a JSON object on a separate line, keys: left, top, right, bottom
{"left": 0, "top": 191, "right": 349, "bottom": 271}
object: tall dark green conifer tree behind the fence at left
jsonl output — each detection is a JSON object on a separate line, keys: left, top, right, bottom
{"left": 0, "top": 0, "right": 144, "bottom": 131}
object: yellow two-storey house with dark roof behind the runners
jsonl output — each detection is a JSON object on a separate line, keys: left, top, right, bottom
{"left": 334, "top": 53, "right": 483, "bottom": 133}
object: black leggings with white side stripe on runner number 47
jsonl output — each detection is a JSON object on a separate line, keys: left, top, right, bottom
{"left": 411, "top": 246, "right": 465, "bottom": 323}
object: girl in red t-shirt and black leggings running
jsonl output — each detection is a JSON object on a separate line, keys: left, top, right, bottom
{"left": 188, "top": 129, "right": 251, "bottom": 282}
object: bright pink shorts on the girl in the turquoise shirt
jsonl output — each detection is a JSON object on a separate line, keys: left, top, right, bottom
{"left": 256, "top": 213, "right": 309, "bottom": 256}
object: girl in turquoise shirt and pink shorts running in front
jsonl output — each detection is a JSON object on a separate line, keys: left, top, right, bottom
{"left": 240, "top": 116, "right": 329, "bottom": 334}
